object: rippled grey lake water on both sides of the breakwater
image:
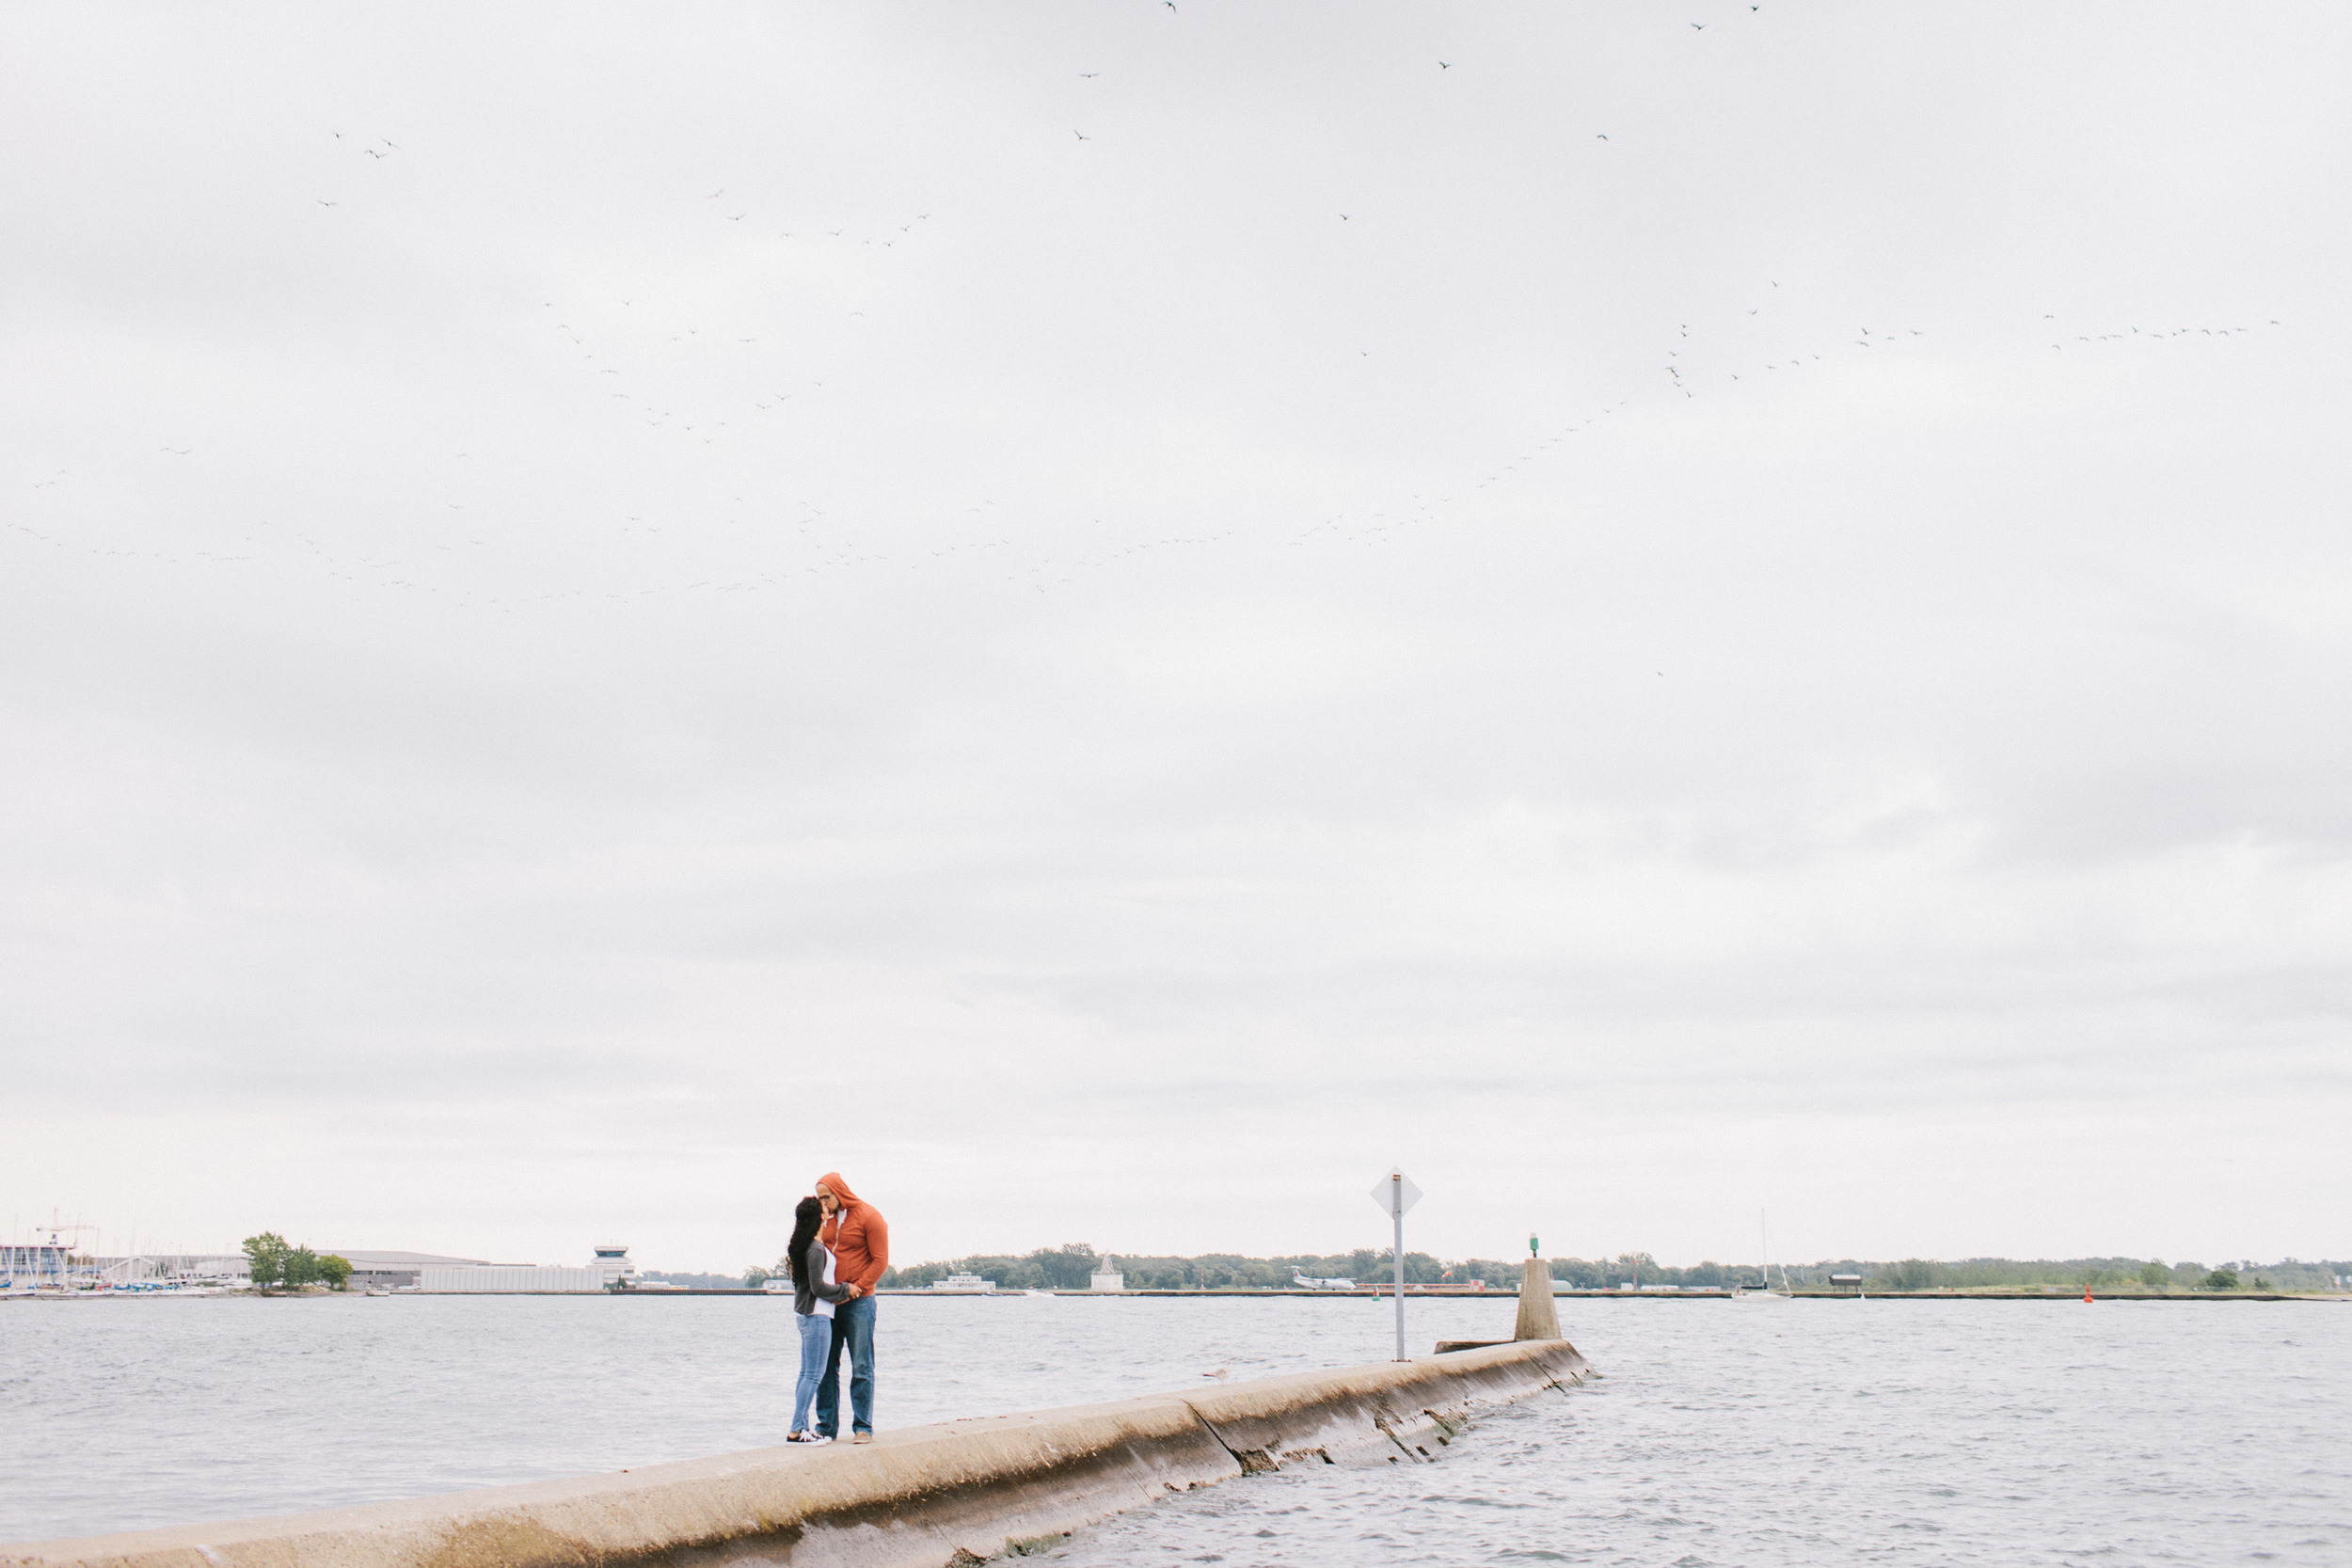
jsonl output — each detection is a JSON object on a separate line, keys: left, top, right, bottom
{"left": 0, "top": 1295, "right": 2352, "bottom": 1568}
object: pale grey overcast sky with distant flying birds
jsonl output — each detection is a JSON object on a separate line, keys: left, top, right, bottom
{"left": 0, "top": 0, "right": 2352, "bottom": 1270}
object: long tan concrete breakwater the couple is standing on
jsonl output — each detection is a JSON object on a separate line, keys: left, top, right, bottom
{"left": 0, "top": 1340, "right": 1593, "bottom": 1568}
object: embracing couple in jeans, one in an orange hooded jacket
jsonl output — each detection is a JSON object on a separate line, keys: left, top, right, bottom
{"left": 784, "top": 1171, "right": 889, "bottom": 1444}
